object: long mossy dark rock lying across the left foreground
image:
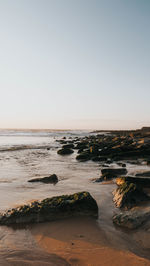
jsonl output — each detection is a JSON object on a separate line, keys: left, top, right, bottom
{"left": 0, "top": 192, "right": 98, "bottom": 225}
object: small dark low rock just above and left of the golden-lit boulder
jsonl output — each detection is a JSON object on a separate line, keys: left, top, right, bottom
{"left": 101, "top": 168, "right": 127, "bottom": 180}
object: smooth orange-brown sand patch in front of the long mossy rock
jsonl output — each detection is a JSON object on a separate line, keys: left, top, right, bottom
{"left": 31, "top": 218, "right": 150, "bottom": 266}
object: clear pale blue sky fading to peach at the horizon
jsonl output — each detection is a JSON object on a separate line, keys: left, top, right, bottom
{"left": 0, "top": 0, "right": 150, "bottom": 129}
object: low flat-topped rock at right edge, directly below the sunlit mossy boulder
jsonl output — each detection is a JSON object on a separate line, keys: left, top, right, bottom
{"left": 113, "top": 210, "right": 150, "bottom": 229}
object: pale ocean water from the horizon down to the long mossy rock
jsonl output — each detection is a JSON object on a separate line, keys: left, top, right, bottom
{"left": 0, "top": 130, "right": 101, "bottom": 210}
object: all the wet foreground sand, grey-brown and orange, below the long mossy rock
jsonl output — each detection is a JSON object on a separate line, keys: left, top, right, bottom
{"left": 0, "top": 218, "right": 150, "bottom": 266}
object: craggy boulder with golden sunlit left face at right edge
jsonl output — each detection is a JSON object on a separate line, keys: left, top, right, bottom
{"left": 113, "top": 178, "right": 150, "bottom": 209}
